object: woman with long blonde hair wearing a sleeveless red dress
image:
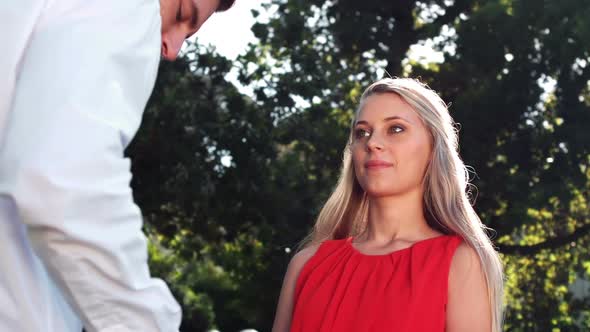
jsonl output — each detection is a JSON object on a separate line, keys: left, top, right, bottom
{"left": 273, "top": 79, "right": 503, "bottom": 332}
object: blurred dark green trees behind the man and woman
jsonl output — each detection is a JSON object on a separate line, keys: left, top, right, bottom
{"left": 127, "top": 0, "right": 590, "bottom": 332}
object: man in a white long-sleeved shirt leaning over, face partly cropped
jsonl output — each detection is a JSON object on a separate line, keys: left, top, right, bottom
{"left": 0, "top": 0, "right": 234, "bottom": 332}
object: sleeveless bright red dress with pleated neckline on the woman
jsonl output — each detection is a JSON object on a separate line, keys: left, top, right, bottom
{"left": 291, "top": 235, "right": 462, "bottom": 332}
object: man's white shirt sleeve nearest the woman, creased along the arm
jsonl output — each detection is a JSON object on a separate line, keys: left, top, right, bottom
{"left": 0, "top": 0, "right": 181, "bottom": 332}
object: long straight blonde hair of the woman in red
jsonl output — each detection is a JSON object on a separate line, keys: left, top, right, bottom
{"left": 305, "top": 78, "right": 503, "bottom": 332}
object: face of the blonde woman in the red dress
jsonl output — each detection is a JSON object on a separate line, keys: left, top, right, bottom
{"left": 351, "top": 93, "right": 432, "bottom": 197}
